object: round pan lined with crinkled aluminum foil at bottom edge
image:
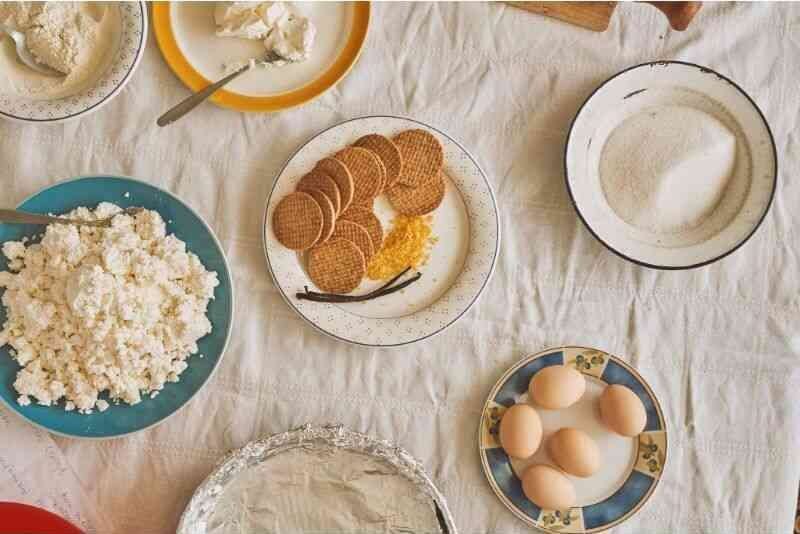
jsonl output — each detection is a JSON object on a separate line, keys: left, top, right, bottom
{"left": 177, "top": 425, "right": 457, "bottom": 534}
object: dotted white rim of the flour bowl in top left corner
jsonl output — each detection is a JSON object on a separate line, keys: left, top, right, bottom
{"left": 0, "top": 2, "right": 147, "bottom": 122}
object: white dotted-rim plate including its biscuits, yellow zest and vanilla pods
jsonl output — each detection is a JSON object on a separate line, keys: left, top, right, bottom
{"left": 263, "top": 116, "right": 500, "bottom": 347}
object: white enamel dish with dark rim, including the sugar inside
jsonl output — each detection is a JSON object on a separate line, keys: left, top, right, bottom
{"left": 564, "top": 61, "right": 777, "bottom": 269}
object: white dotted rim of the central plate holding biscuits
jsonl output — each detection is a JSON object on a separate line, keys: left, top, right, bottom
{"left": 263, "top": 116, "right": 500, "bottom": 347}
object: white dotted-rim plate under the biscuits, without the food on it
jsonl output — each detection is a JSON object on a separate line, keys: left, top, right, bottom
{"left": 264, "top": 116, "right": 500, "bottom": 347}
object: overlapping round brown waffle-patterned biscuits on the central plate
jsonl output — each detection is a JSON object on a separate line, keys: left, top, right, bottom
{"left": 272, "top": 130, "right": 445, "bottom": 293}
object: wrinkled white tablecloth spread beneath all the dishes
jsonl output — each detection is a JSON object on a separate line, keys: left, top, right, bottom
{"left": 0, "top": 3, "right": 800, "bottom": 534}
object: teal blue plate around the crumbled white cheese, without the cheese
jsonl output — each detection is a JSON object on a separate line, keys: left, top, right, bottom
{"left": 0, "top": 176, "right": 233, "bottom": 439}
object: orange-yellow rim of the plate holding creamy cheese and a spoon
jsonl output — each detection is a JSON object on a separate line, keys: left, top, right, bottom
{"left": 153, "top": 2, "right": 370, "bottom": 111}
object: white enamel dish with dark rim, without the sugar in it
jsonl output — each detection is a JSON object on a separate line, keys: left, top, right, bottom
{"left": 565, "top": 61, "right": 777, "bottom": 269}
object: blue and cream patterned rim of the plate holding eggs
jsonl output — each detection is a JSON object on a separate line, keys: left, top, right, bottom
{"left": 478, "top": 346, "right": 667, "bottom": 534}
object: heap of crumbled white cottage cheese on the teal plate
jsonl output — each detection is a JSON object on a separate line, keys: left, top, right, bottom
{"left": 0, "top": 202, "right": 219, "bottom": 413}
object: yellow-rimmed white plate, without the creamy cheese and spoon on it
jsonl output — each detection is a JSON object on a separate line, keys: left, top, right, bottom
{"left": 152, "top": 2, "right": 370, "bottom": 111}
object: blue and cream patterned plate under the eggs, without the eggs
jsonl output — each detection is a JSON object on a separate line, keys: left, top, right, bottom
{"left": 479, "top": 347, "right": 667, "bottom": 534}
